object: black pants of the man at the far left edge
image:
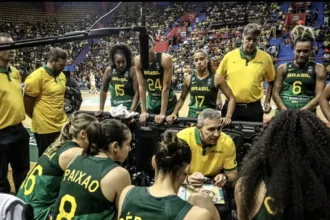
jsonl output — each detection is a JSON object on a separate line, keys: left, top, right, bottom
{"left": 0, "top": 124, "right": 30, "bottom": 193}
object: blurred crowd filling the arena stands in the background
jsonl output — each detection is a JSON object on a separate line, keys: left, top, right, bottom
{"left": 0, "top": 2, "right": 330, "bottom": 89}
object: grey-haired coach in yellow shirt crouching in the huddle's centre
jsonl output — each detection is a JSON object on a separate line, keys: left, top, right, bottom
{"left": 177, "top": 108, "right": 238, "bottom": 186}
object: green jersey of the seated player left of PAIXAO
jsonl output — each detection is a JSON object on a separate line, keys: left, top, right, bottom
{"left": 17, "top": 141, "right": 79, "bottom": 219}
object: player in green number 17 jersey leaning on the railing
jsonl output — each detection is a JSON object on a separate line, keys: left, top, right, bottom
{"left": 166, "top": 49, "right": 235, "bottom": 125}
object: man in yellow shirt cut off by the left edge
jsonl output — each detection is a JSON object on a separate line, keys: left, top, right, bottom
{"left": 0, "top": 33, "right": 30, "bottom": 193}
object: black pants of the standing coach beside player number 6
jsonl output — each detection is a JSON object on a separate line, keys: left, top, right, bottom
{"left": 221, "top": 100, "right": 264, "bottom": 122}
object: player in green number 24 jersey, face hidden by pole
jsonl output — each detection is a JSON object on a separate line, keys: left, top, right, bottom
{"left": 135, "top": 35, "right": 177, "bottom": 124}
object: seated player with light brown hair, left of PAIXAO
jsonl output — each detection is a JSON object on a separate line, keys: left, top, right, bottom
{"left": 17, "top": 114, "right": 97, "bottom": 219}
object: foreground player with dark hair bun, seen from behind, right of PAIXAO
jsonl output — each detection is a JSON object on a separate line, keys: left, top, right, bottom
{"left": 118, "top": 131, "right": 220, "bottom": 220}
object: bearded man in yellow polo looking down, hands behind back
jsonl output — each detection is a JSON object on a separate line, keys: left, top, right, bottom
{"left": 24, "top": 48, "right": 68, "bottom": 157}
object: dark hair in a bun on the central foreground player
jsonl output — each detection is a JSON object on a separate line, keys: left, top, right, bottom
{"left": 155, "top": 131, "right": 191, "bottom": 178}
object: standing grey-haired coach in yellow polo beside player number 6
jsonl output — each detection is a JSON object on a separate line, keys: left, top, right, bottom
{"left": 217, "top": 24, "right": 275, "bottom": 122}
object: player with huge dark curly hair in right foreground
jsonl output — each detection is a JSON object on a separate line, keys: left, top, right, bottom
{"left": 235, "top": 110, "right": 330, "bottom": 220}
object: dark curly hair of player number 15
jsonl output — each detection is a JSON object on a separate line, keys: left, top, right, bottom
{"left": 110, "top": 44, "right": 133, "bottom": 69}
